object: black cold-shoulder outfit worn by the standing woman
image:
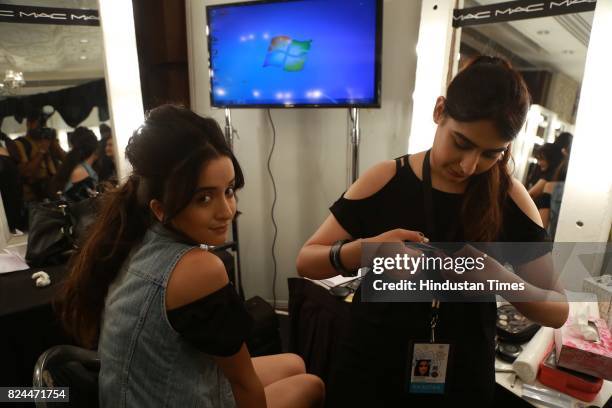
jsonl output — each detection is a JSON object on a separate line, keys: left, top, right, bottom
{"left": 327, "top": 156, "right": 548, "bottom": 407}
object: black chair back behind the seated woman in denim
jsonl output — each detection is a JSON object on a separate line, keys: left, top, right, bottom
{"left": 32, "top": 345, "right": 100, "bottom": 408}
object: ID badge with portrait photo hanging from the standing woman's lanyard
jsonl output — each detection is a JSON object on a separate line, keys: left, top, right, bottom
{"left": 406, "top": 342, "right": 451, "bottom": 394}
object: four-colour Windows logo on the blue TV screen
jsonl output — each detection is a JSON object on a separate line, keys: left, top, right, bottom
{"left": 264, "top": 35, "right": 312, "bottom": 72}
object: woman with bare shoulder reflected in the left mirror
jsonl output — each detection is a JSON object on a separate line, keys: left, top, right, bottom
{"left": 51, "top": 126, "right": 98, "bottom": 201}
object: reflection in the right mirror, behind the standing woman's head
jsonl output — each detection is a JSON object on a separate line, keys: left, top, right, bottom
{"left": 457, "top": 0, "right": 594, "bottom": 242}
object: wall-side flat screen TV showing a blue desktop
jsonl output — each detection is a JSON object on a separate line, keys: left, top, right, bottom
{"left": 206, "top": 0, "right": 382, "bottom": 108}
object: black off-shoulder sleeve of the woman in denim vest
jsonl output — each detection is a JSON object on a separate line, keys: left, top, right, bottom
{"left": 167, "top": 284, "right": 253, "bottom": 357}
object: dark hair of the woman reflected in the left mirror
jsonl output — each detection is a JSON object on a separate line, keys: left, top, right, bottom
{"left": 50, "top": 126, "right": 98, "bottom": 196}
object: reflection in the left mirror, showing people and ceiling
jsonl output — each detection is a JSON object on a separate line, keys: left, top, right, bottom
{"left": 0, "top": 0, "right": 115, "bottom": 242}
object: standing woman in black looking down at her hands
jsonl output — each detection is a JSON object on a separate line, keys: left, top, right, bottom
{"left": 297, "top": 57, "right": 568, "bottom": 407}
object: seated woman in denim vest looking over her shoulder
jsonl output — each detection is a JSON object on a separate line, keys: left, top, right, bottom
{"left": 60, "top": 105, "right": 324, "bottom": 408}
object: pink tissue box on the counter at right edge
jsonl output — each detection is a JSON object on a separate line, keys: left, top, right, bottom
{"left": 555, "top": 317, "right": 612, "bottom": 380}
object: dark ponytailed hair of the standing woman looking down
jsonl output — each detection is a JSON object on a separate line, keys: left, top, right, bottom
{"left": 444, "top": 56, "right": 530, "bottom": 241}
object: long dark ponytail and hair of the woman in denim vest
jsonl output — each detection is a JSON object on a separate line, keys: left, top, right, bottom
{"left": 57, "top": 105, "right": 244, "bottom": 347}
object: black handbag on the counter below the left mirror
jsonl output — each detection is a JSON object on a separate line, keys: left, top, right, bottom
{"left": 26, "top": 198, "right": 97, "bottom": 267}
